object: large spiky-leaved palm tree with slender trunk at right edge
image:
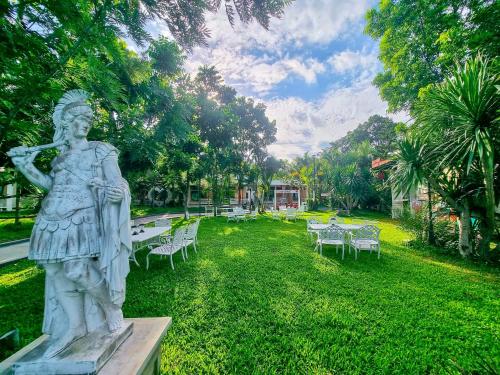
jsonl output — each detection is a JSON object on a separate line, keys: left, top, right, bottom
{"left": 415, "top": 55, "right": 500, "bottom": 256}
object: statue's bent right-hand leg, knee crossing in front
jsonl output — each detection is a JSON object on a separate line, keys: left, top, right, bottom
{"left": 67, "top": 259, "right": 123, "bottom": 332}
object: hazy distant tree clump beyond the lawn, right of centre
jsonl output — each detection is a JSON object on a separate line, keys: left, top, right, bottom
{"left": 282, "top": 115, "right": 398, "bottom": 210}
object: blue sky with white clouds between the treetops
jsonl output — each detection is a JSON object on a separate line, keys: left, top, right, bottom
{"left": 138, "top": 0, "right": 406, "bottom": 159}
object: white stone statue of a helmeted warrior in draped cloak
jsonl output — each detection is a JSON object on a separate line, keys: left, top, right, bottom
{"left": 8, "top": 90, "right": 132, "bottom": 358}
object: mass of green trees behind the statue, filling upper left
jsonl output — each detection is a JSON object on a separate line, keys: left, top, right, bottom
{"left": 0, "top": 0, "right": 280, "bottom": 214}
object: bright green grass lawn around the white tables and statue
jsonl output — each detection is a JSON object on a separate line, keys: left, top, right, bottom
{"left": 0, "top": 213, "right": 500, "bottom": 374}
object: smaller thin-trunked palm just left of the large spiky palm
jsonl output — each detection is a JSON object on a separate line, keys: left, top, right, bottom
{"left": 389, "top": 135, "right": 436, "bottom": 245}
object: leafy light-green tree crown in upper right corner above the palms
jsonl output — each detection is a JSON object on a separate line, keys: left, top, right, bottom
{"left": 365, "top": 0, "right": 500, "bottom": 111}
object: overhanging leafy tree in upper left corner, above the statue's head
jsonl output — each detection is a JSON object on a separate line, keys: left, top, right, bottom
{"left": 0, "top": 0, "right": 290, "bottom": 164}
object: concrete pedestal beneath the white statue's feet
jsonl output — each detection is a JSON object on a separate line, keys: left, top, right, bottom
{"left": 0, "top": 317, "right": 172, "bottom": 375}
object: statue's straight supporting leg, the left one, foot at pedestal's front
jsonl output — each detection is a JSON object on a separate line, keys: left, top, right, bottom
{"left": 44, "top": 263, "right": 87, "bottom": 358}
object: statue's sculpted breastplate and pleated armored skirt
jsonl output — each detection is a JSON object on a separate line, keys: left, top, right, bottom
{"left": 29, "top": 142, "right": 111, "bottom": 263}
